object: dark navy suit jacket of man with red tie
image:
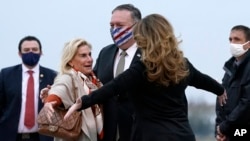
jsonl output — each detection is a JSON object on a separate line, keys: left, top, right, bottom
{"left": 0, "top": 64, "right": 56, "bottom": 141}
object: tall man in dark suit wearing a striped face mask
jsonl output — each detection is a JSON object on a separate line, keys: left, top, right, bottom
{"left": 94, "top": 4, "right": 141, "bottom": 141}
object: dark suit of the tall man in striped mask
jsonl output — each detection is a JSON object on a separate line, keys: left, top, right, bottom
{"left": 94, "top": 44, "right": 141, "bottom": 141}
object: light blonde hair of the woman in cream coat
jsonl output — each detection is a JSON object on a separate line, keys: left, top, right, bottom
{"left": 59, "top": 38, "right": 92, "bottom": 74}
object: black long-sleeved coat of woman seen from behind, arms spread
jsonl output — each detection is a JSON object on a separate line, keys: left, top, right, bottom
{"left": 85, "top": 61, "right": 224, "bottom": 141}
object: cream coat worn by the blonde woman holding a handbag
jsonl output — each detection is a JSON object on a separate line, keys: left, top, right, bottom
{"left": 49, "top": 70, "right": 97, "bottom": 141}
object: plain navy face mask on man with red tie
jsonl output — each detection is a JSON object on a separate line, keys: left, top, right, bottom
{"left": 22, "top": 52, "right": 40, "bottom": 66}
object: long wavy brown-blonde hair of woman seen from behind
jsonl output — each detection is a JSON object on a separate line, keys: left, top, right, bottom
{"left": 133, "top": 14, "right": 189, "bottom": 86}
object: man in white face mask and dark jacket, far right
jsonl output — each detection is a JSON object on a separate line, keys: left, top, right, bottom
{"left": 215, "top": 25, "right": 250, "bottom": 141}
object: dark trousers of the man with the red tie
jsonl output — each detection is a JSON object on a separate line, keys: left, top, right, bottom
{"left": 16, "top": 133, "right": 39, "bottom": 141}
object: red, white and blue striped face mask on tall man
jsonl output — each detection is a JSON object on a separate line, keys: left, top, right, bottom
{"left": 110, "top": 25, "right": 133, "bottom": 47}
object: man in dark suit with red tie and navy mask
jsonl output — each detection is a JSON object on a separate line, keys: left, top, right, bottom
{"left": 0, "top": 36, "right": 56, "bottom": 141}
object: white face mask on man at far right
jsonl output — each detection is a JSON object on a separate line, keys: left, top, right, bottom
{"left": 230, "top": 41, "right": 249, "bottom": 57}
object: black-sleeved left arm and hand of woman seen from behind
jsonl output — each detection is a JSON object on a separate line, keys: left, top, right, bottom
{"left": 64, "top": 61, "right": 147, "bottom": 118}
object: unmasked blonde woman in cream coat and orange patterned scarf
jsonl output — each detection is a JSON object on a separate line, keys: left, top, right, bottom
{"left": 44, "top": 38, "right": 103, "bottom": 141}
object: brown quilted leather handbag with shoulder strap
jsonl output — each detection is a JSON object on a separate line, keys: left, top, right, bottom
{"left": 37, "top": 73, "right": 82, "bottom": 140}
